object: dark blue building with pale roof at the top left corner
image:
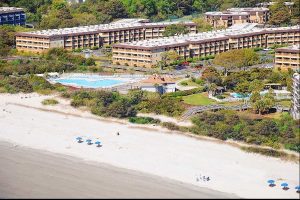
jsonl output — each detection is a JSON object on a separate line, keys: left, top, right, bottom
{"left": 0, "top": 7, "right": 26, "bottom": 26}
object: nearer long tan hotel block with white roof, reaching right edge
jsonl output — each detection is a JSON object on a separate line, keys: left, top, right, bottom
{"left": 112, "top": 23, "right": 300, "bottom": 67}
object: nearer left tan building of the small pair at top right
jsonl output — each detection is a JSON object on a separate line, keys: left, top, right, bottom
{"left": 205, "top": 11, "right": 250, "bottom": 28}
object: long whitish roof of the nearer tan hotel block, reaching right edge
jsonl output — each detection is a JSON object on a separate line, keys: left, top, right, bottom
{"left": 113, "top": 23, "right": 300, "bottom": 50}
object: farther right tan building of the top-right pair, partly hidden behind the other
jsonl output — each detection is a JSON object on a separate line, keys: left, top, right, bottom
{"left": 227, "top": 7, "right": 270, "bottom": 24}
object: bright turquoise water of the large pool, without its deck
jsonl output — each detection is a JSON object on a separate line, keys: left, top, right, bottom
{"left": 52, "top": 76, "right": 126, "bottom": 88}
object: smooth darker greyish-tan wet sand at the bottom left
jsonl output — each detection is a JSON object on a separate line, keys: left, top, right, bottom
{"left": 0, "top": 142, "right": 236, "bottom": 198}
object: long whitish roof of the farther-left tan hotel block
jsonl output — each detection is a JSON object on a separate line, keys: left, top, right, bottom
{"left": 17, "top": 19, "right": 195, "bottom": 37}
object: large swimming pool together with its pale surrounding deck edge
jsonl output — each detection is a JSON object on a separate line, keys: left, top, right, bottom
{"left": 50, "top": 75, "right": 142, "bottom": 88}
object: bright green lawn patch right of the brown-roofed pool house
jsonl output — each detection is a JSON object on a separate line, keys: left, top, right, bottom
{"left": 183, "top": 93, "right": 217, "bottom": 106}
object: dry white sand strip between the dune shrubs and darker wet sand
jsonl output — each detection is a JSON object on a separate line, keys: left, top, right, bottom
{"left": 0, "top": 94, "right": 299, "bottom": 198}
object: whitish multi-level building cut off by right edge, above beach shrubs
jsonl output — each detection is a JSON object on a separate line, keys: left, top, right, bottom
{"left": 291, "top": 73, "right": 300, "bottom": 120}
